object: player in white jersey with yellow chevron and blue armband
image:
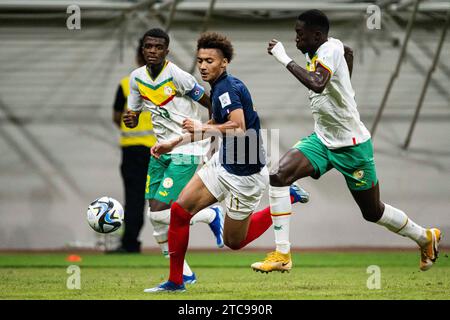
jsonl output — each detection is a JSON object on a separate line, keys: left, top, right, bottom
{"left": 124, "top": 29, "right": 224, "bottom": 283}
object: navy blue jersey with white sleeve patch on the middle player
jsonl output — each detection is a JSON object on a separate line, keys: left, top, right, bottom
{"left": 211, "top": 72, "right": 265, "bottom": 176}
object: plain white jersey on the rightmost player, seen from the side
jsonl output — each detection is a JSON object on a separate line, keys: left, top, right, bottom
{"left": 306, "top": 38, "right": 370, "bottom": 149}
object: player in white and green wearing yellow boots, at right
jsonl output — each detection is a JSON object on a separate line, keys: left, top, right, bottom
{"left": 252, "top": 10, "right": 441, "bottom": 272}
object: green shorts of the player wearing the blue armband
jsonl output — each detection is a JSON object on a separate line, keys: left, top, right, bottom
{"left": 145, "top": 154, "right": 200, "bottom": 204}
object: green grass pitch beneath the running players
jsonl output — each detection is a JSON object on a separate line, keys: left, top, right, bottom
{"left": 0, "top": 250, "right": 450, "bottom": 300}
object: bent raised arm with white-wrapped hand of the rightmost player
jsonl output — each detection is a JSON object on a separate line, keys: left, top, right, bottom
{"left": 267, "top": 40, "right": 331, "bottom": 93}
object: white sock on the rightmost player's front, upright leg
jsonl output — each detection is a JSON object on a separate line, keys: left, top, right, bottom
{"left": 269, "top": 186, "right": 292, "bottom": 254}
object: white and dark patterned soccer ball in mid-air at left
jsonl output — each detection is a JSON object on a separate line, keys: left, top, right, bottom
{"left": 87, "top": 197, "right": 123, "bottom": 233}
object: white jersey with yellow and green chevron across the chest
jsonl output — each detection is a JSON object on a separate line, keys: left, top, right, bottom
{"left": 128, "top": 61, "right": 209, "bottom": 156}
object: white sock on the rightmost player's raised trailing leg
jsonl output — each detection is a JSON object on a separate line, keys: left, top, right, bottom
{"left": 377, "top": 203, "right": 429, "bottom": 247}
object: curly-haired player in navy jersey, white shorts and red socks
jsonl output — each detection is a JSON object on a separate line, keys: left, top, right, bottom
{"left": 144, "top": 33, "right": 307, "bottom": 292}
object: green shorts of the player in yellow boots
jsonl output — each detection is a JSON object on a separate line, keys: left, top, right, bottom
{"left": 294, "top": 133, "right": 378, "bottom": 191}
